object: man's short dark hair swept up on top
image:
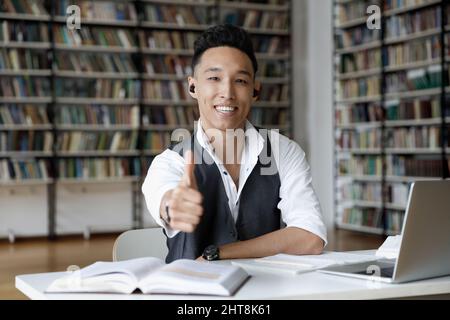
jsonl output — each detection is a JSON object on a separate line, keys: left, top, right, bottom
{"left": 191, "top": 24, "right": 258, "bottom": 75}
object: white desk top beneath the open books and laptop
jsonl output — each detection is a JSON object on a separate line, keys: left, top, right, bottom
{"left": 16, "top": 251, "right": 450, "bottom": 300}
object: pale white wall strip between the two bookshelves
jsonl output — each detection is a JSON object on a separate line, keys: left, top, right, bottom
{"left": 292, "top": 0, "right": 334, "bottom": 227}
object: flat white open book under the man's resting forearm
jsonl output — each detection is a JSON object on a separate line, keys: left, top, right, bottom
{"left": 232, "top": 251, "right": 379, "bottom": 274}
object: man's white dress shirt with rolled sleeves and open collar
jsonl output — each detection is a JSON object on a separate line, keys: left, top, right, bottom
{"left": 142, "top": 121, "right": 327, "bottom": 244}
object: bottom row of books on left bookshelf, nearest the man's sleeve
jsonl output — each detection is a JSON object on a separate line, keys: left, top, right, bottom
{"left": 58, "top": 158, "right": 142, "bottom": 179}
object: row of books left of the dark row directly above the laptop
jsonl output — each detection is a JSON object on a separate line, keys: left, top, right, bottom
{"left": 338, "top": 155, "right": 383, "bottom": 176}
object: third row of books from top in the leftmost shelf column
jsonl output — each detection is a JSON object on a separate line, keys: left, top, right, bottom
{"left": 0, "top": 48, "right": 50, "bottom": 70}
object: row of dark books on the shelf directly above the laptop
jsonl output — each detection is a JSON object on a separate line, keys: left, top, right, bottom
{"left": 386, "top": 155, "right": 443, "bottom": 177}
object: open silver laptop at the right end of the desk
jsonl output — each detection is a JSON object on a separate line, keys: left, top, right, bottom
{"left": 318, "top": 180, "right": 450, "bottom": 283}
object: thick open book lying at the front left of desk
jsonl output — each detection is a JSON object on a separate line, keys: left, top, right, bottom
{"left": 46, "top": 257, "right": 248, "bottom": 296}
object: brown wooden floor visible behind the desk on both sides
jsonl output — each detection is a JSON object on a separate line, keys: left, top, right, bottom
{"left": 0, "top": 230, "right": 384, "bottom": 300}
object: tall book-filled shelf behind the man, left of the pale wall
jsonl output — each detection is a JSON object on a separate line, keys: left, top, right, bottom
{"left": 0, "top": 0, "right": 292, "bottom": 239}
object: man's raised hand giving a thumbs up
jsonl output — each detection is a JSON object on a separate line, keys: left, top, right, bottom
{"left": 160, "top": 150, "right": 203, "bottom": 232}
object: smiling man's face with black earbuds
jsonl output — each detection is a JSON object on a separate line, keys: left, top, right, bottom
{"left": 189, "top": 47, "right": 256, "bottom": 130}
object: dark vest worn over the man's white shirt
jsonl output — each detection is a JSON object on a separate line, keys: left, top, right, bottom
{"left": 166, "top": 133, "right": 281, "bottom": 263}
